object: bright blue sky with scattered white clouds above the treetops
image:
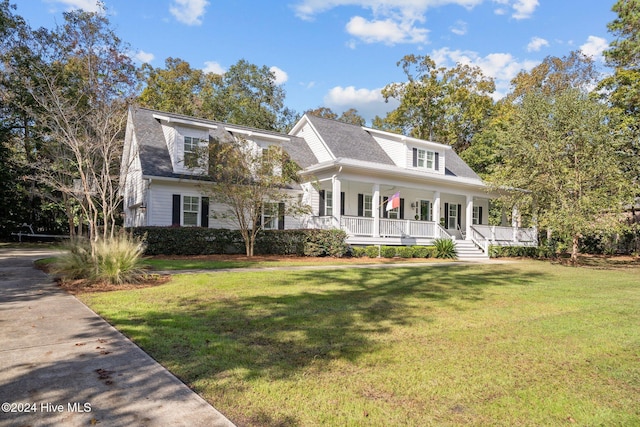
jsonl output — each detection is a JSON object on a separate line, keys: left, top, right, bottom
{"left": 10, "top": 0, "right": 615, "bottom": 120}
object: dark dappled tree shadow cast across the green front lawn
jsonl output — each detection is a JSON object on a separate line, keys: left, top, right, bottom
{"left": 94, "top": 265, "right": 542, "bottom": 425}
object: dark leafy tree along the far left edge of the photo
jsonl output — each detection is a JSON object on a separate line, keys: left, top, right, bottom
{"left": 0, "top": 0, "right": 69, "bottom": 237}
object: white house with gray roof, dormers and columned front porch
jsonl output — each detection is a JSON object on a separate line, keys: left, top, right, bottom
{"left": 122, "top": 108, "right": 537, "bottom": 256}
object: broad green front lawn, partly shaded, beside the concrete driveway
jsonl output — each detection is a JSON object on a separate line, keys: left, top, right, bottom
{"left": 81, "top": 261, "right": 640, "bottom": 426}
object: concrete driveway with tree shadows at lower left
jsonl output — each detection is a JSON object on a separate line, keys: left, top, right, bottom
{"left": 0, "top": 249, "right": 233, "bottom": 426}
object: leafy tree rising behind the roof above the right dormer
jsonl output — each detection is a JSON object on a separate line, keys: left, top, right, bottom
{"left": 374, "top": 55, "right": 495, "bottom": 152}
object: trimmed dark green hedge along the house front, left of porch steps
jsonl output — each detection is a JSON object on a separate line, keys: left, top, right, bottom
{"left": 130, "top": 227, "right": 347, "bottom": 257}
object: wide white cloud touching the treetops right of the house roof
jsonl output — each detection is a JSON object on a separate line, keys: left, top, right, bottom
{"left": 430, "top": 48, "right": 539, "bottom": 100}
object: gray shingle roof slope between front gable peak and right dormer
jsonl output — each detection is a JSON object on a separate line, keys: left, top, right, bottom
{"left": 307, "top": 114, "right": 395, "bottom": 165}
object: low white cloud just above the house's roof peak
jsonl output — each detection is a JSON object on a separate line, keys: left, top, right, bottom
{"left": 324, "top": 86, "right": 398, "bottom": 122}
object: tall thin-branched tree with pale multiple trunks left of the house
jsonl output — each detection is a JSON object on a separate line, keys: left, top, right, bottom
{"left": 11, "top": 5, "right": 136, "bottom": 241}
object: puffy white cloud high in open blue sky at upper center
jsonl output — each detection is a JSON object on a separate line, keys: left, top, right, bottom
{"left": 346, "top": 16, "right": 427, "bottom": 45}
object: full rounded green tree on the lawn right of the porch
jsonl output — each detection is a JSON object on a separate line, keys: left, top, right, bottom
{"left": 491, "top": 89, "right": 630, "bottom": 262}
